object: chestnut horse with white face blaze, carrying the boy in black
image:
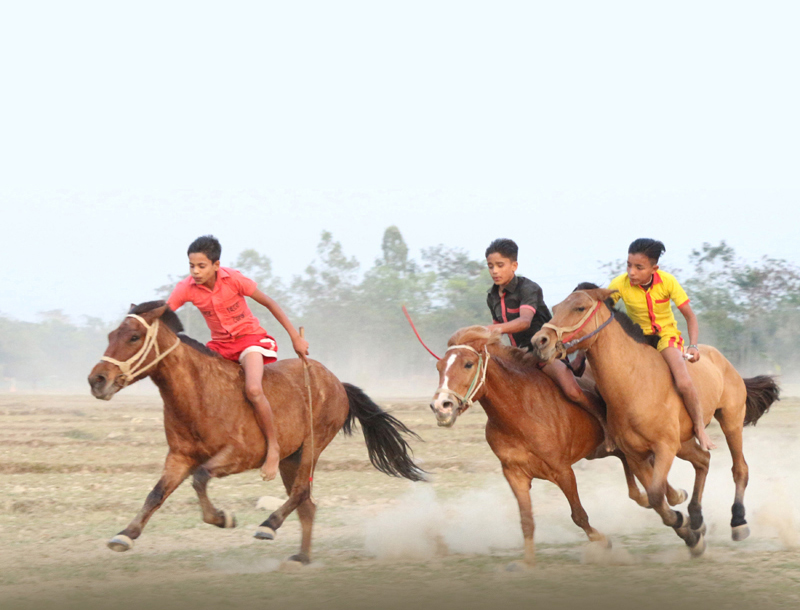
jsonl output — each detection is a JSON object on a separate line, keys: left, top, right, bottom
{"left": 430, "top": 326, "right": 688, "bottom": 566}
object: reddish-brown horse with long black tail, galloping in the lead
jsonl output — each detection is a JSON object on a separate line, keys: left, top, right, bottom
{"left": 89, "top": 301, "right": 423, "bottom": 564}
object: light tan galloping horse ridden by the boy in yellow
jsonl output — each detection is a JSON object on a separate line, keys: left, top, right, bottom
{"left": 532, "top": 288, "right": 780, "bottom": 557}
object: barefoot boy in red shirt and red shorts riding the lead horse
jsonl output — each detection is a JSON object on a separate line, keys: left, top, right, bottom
{"left": 167, "top": 235, "right": 308, "bottom": 481}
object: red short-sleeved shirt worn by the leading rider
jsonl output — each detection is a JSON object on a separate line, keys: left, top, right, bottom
{"left": 167, "top": 267, "right": 266, "bottom": 341}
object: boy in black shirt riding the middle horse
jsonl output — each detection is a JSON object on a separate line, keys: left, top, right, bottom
{"left": 486, "top": 239, "right": 608, "bottom": 437}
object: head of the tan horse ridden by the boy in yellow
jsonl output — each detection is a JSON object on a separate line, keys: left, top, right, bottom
{"left": 531, "top": 288, "right": 616, "bottom": 362}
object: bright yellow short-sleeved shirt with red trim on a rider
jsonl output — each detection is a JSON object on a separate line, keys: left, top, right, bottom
{"left": 608, "top": 270, "right": 689, "bottom": 335}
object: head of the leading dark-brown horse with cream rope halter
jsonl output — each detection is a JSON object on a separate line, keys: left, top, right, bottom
{"left": 89, "top": 301, "right": 183, "bottom": 400}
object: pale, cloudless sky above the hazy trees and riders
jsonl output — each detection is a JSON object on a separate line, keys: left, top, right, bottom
{"left": 0, "top": 1, "right": 800, "bottom": 322}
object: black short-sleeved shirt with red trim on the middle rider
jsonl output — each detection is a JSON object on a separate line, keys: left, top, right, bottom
{"left": 486, "top": 275, "right": 553, "bottom": 349}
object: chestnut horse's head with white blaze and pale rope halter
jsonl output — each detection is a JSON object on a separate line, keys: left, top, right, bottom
{"left": 431, "top": 326, "right": 499, "bottom": 428}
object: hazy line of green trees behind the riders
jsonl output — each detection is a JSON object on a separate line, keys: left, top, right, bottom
{"left": 0, "top": 227, "right": 800, "bottom": 396}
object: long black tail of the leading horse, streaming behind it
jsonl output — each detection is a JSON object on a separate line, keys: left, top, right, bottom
{"left": 342, "top": 383, "right": 425, "bottom": 481}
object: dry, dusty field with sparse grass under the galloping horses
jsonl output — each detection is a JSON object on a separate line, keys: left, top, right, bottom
{"left": 0, "top": 393, "right": 800, "bottom": 609}
